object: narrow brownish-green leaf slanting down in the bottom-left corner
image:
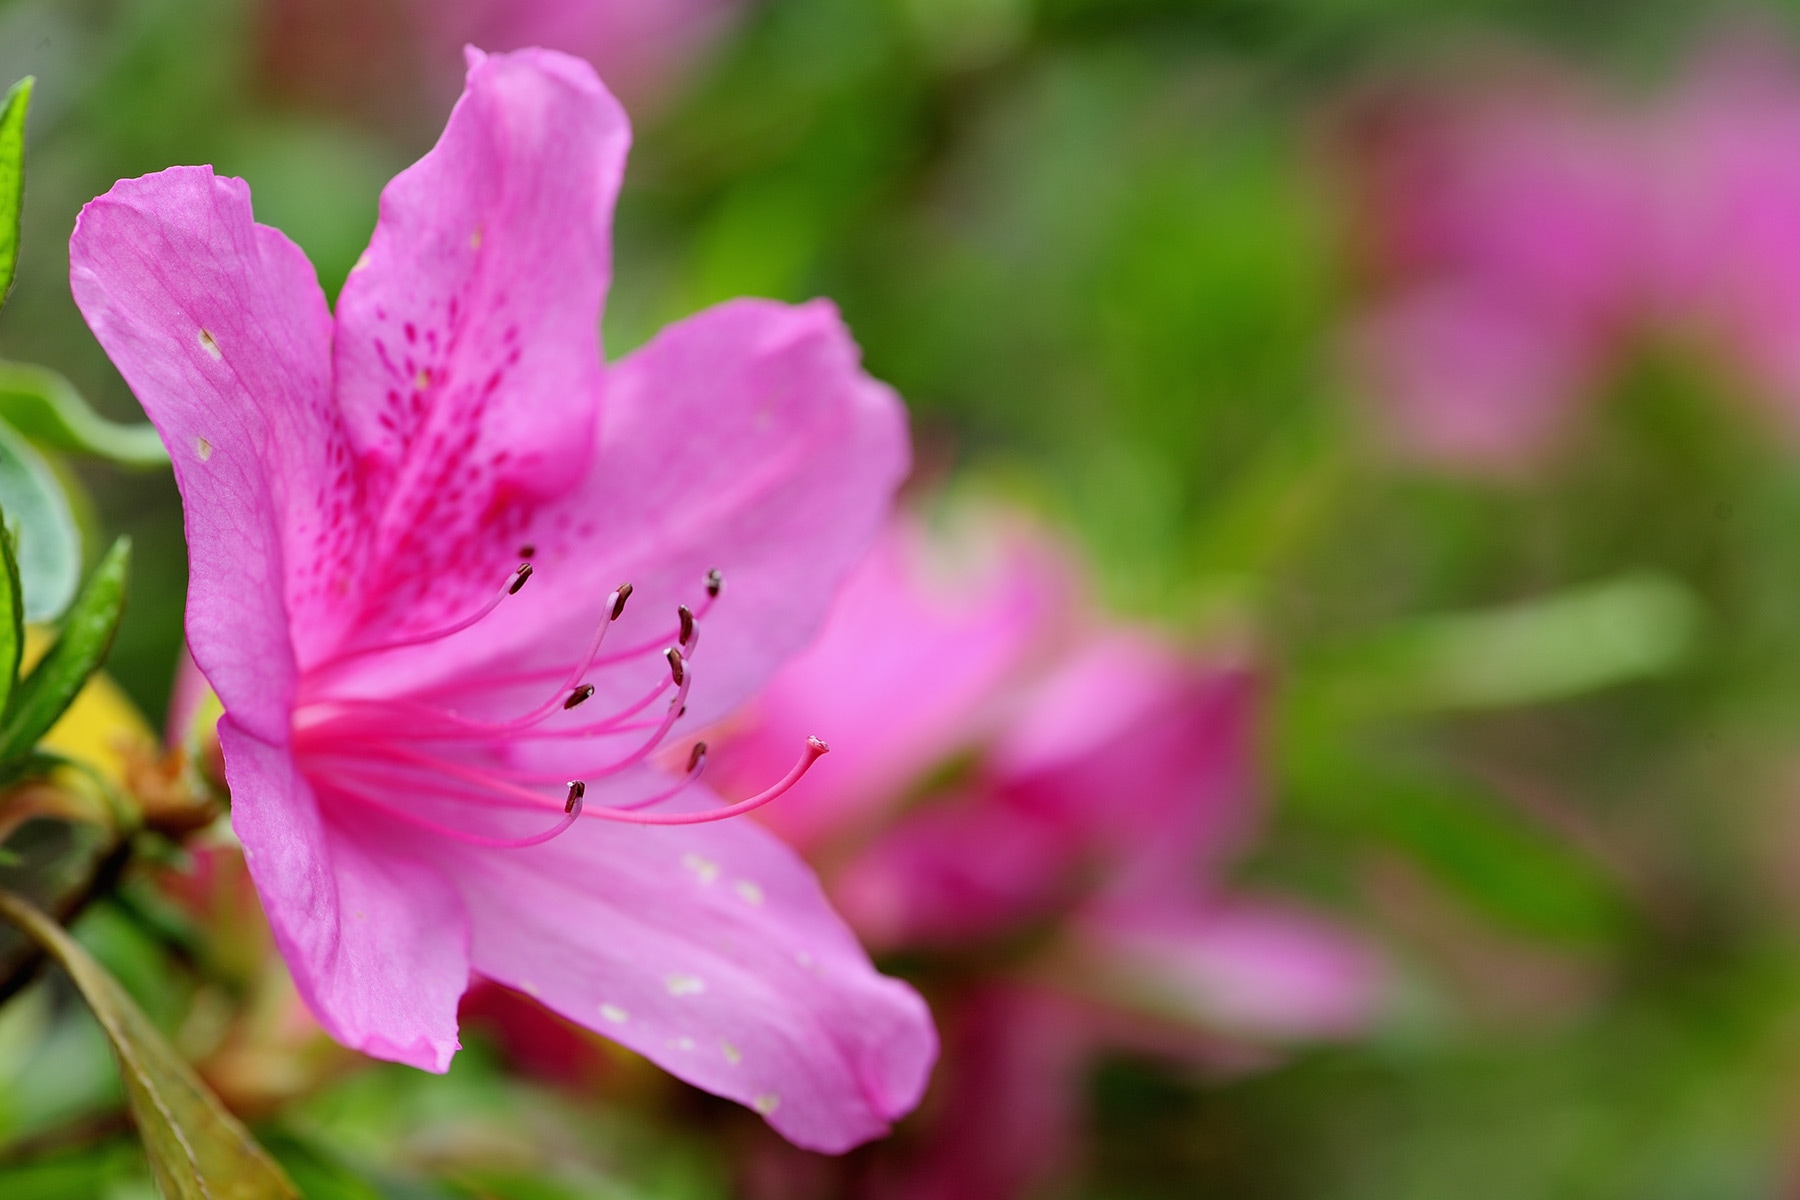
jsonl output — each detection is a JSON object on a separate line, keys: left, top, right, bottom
{"left": 0, "top": 891, "right": 299, "bottom": 1200}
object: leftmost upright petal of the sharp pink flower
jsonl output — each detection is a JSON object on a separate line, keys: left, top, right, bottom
{"left": 68, "top": 167, "right": 342, "bottom": 741}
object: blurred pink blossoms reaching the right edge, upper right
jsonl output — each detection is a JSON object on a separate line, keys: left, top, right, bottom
{"left": 1350, "top": 45, "right": 1800, "bottom": 473}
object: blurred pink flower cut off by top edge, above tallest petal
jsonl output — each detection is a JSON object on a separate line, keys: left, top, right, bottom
{"left": 410, "top": 0, "right": 747, "bottom": 112}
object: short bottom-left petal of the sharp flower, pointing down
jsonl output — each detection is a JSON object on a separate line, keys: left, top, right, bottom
{"left": 220, "top": 716, "right": 468, "bottom": 1070}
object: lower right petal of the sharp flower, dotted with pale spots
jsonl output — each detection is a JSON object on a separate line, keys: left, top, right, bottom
{"left": 432, "top": 780, "right": 936, "bottom": 1151}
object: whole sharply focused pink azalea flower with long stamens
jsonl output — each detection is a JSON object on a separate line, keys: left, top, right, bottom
{"left": 70, "top": 50, "right": 934, "bottom": 1151}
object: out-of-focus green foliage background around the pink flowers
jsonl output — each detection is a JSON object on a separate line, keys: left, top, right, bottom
{"left": 17, "top": 0, "right": 1800, "bottom": 1200}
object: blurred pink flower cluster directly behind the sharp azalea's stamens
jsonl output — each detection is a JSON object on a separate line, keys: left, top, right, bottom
{"left": 715, "top": 507, "right": 1381, "bottom": 1198}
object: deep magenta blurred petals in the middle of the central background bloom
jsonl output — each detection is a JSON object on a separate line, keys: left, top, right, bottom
{"left": 835, "top": 633, "right": 1255, "bottom": 946}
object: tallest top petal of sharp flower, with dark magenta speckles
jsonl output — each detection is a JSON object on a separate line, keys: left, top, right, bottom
{"left": 335, "top": 50, "right": 630, "bottom": 658}
